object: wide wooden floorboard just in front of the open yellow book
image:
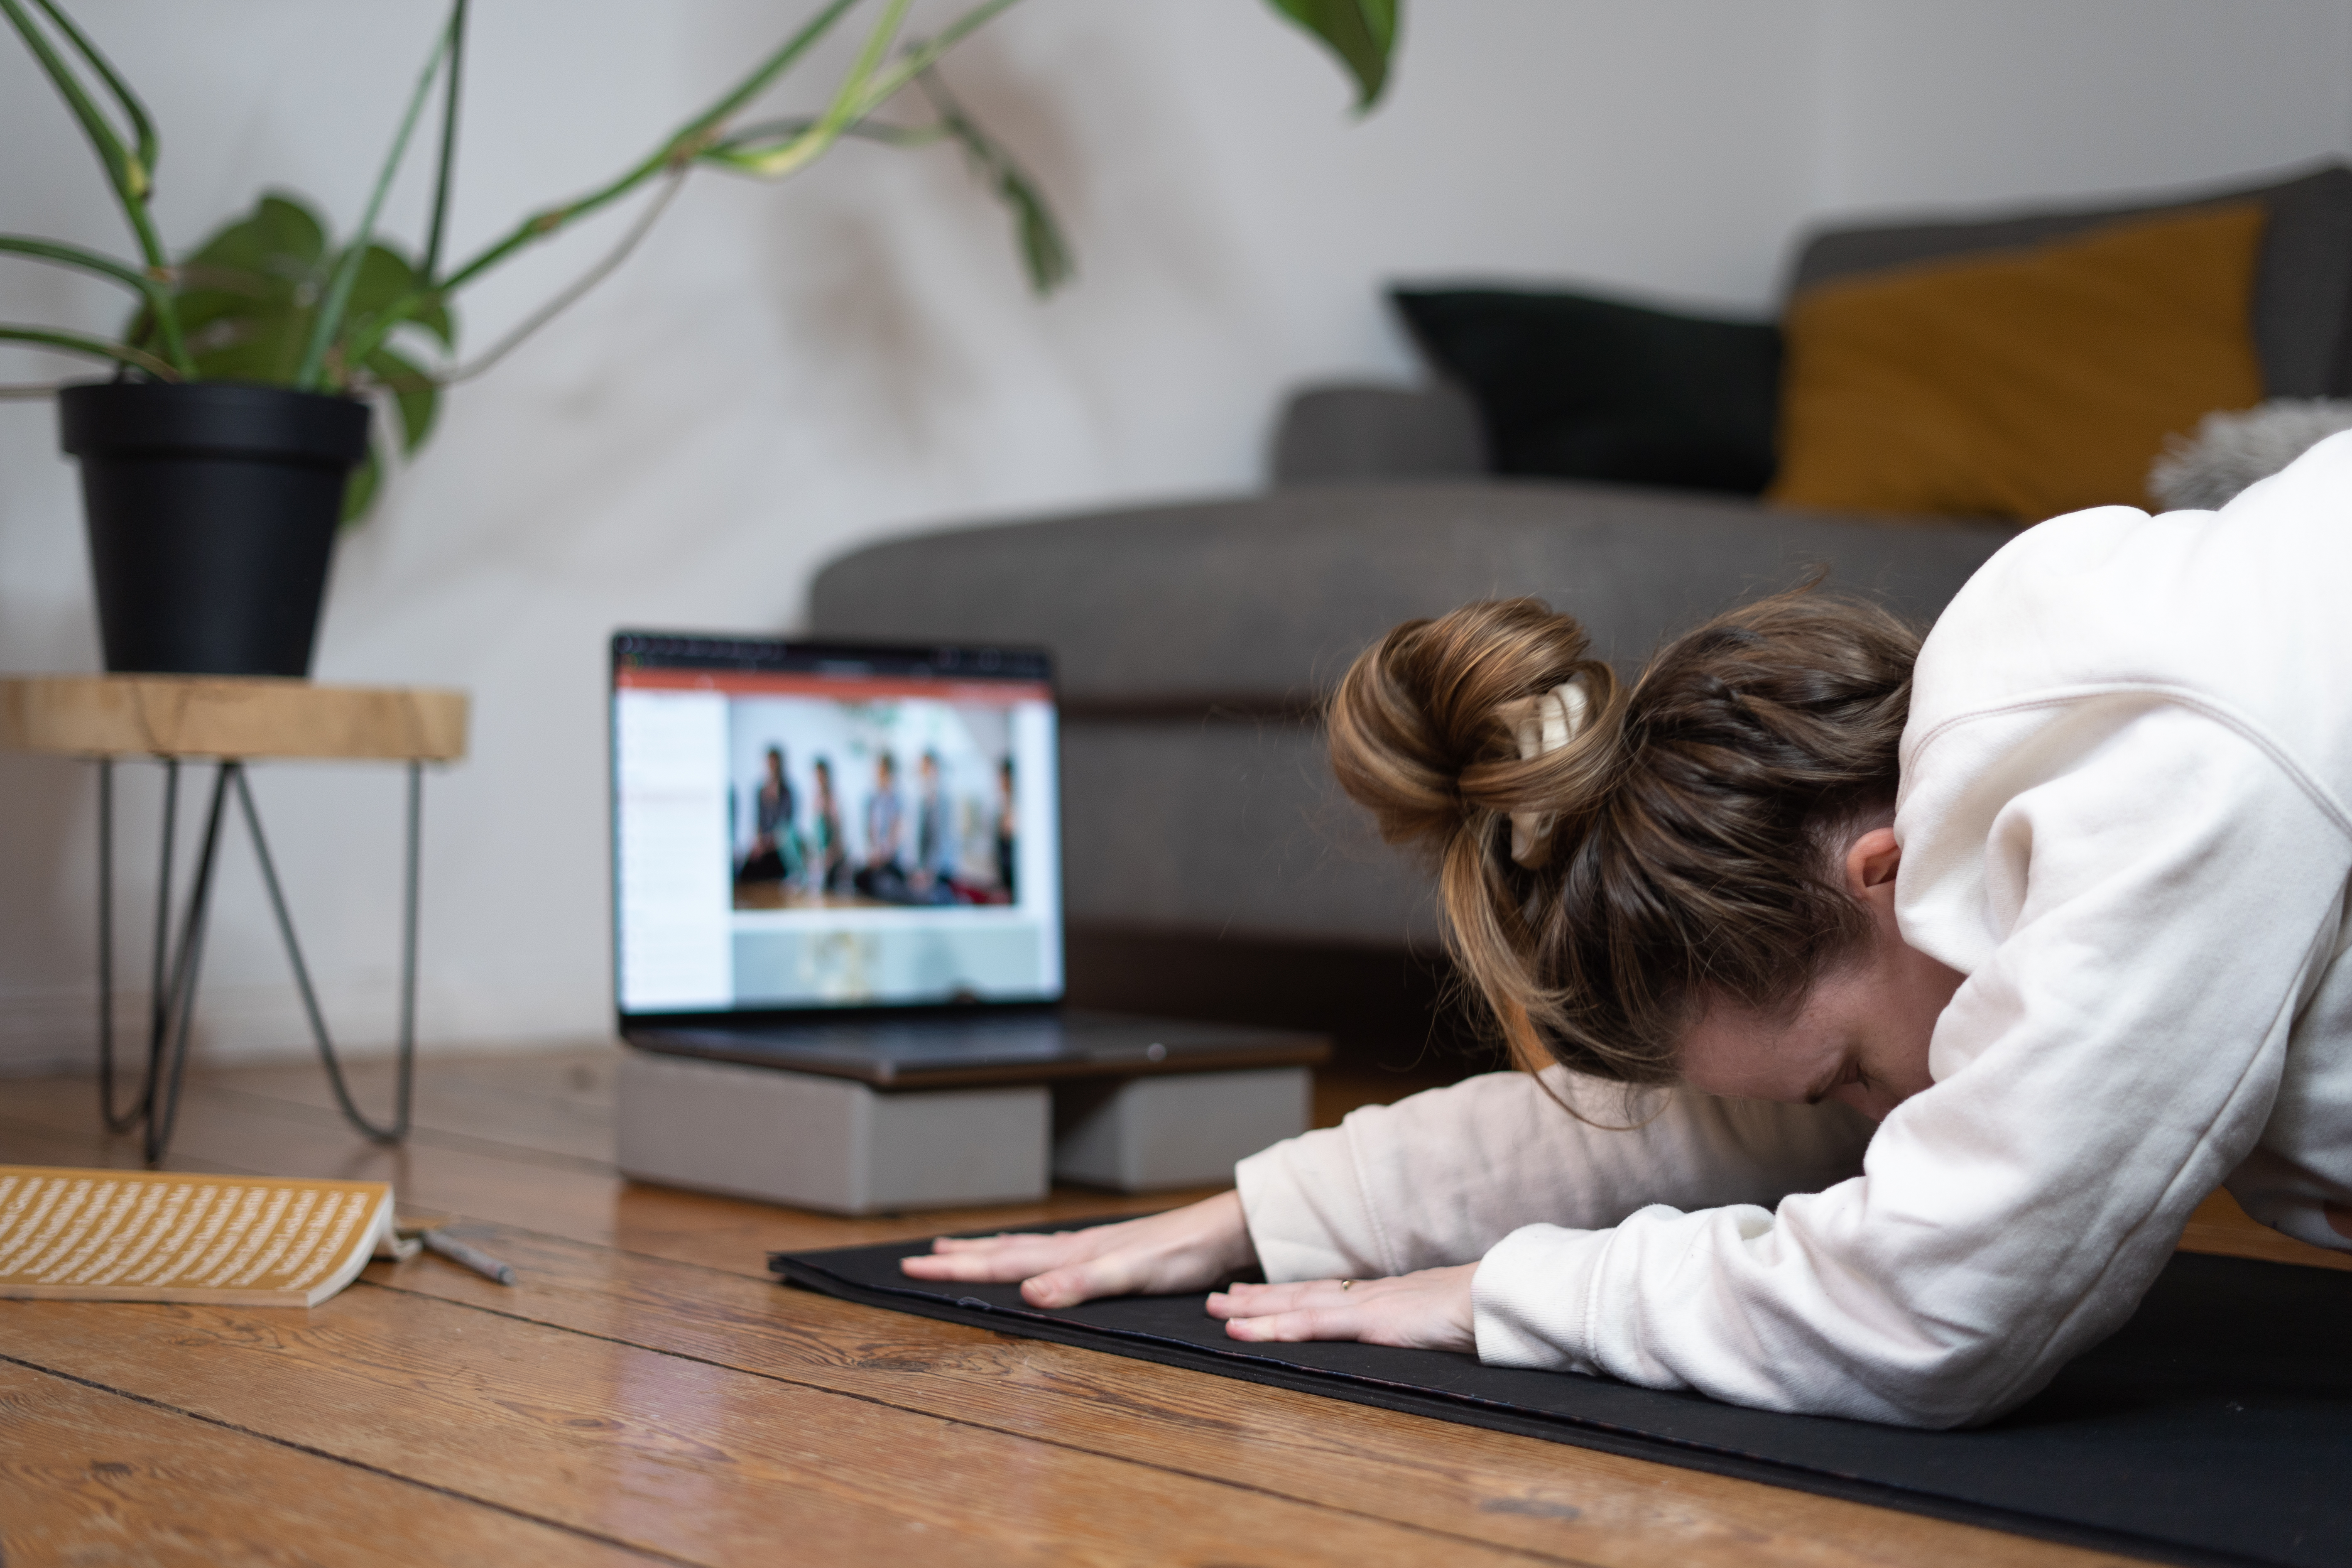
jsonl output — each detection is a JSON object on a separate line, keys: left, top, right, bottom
{"left": 0, "top": 1286, "right": 1559, "bottom": 1568}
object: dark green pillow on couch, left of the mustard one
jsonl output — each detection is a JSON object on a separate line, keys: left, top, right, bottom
{"left": 1392, "top": 289, "right": 1781, "bottom": 496}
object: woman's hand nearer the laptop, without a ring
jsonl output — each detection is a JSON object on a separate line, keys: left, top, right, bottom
{"left": 899, "top": 1192, "right": 1258, "bottom": 1307}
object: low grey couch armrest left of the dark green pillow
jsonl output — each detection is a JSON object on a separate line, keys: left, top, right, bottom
{"left": 1270, "top": 383, "right": 1487, "bottom": 487}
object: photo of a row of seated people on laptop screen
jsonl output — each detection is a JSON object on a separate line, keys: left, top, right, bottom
{"left": 729, "top": 696, "right": 1019, "bottom": 910}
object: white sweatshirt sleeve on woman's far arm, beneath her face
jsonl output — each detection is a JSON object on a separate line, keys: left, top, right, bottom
{"left": 1235, "top": 1067, "right": 1872, "bottom": 1281}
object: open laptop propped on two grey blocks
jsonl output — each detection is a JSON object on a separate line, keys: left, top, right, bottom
{"left": 612, "top": 630, "right": 1329, "bottom": 1088}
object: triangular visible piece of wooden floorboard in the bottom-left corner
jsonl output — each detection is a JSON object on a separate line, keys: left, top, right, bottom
{"left": 0, "top": 1359, "right": 661, "bottom": 1568}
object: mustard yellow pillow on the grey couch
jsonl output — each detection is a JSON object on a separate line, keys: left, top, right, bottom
{"left": 1766, "top": 202, "right": 2265, "bottom": 522}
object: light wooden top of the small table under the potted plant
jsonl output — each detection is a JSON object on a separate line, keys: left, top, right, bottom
{"left": 0, "top": 675, "right": 468, "bottom": 762}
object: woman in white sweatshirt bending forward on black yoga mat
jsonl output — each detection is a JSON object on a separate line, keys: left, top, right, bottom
{"left": 908, "top": 437, "right": 2352, "bottom": 1425}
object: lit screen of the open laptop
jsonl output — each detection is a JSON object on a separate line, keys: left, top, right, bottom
{"left": 612, "top": 632, "right": 1063, "bottom": 1016}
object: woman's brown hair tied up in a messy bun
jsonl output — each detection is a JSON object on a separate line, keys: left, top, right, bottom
{"left": 1329, "top": 588, "right": 1919, "bottom": 1084}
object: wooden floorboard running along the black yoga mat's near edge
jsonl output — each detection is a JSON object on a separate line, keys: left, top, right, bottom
{"left": 343, "top": 1227, "right": 2110, "bottom": 1568}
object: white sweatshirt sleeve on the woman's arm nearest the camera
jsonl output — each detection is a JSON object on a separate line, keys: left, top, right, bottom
{"left": 1472, "top": 693, "right": 2347, "bottom": 1427}
